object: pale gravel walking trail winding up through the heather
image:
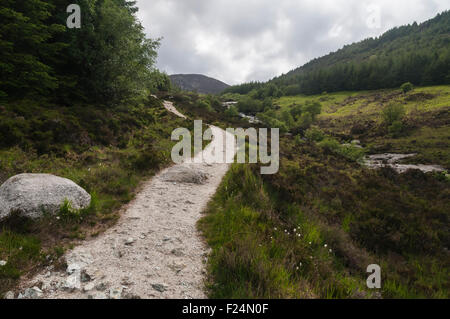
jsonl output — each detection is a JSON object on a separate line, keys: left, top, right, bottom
{"left": 18, "top": 102, "right": 235, "bottom": 299}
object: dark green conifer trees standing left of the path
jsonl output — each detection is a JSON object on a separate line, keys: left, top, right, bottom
{"left": 0, "top": 0, "right": 170, "bottom": 104}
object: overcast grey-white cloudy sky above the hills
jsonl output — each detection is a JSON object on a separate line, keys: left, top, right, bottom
{"left": 138, "top": 0, "right": 450, "bottom": 84}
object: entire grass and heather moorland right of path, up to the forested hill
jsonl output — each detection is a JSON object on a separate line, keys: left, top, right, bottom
{"left": 199, "top": 85, "right": 450, "bottom": 298}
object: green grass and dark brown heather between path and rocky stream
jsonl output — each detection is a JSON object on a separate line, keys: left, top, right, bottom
{"left": 199, "top": 139, "right": 450, "bottom": 298}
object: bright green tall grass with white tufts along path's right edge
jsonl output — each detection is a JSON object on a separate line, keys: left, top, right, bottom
{"left": 199, "top": 165, "right": 370, "bottom": 298}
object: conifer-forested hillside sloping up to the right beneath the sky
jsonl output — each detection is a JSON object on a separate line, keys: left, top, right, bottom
{"left": 227, "top": 11, "right": 450, "bottom": 98}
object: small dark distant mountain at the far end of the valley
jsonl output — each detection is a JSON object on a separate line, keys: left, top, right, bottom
{"left": 170, "top": 74, "right": 229, "bottom": 94}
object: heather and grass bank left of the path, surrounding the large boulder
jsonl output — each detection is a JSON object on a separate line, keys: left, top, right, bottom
{"left": 0, "top": 99, "right": 197, "bottom": 296}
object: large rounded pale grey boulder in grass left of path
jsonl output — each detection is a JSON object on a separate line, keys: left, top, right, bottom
{"left": 0, "top": 174, "right": 91, "bottom": 220}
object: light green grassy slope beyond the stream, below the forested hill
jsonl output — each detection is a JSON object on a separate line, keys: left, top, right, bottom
{"left": 275, "top": 85, "right": 450, "bottom": 170}
